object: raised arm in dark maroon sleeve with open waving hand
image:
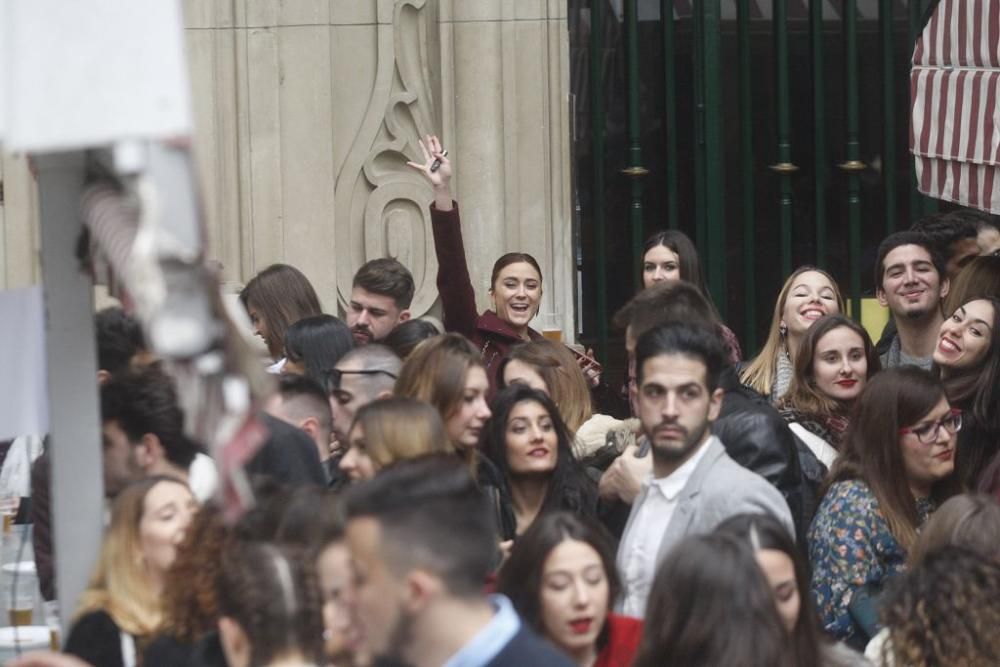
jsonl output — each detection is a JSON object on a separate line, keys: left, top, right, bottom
{"left": 406, "top": 136, "right": 479, "bottom": 338}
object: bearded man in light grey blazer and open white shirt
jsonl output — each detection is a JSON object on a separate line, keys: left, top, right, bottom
{"left": 617, "top": 323, "right": 795, "bottom": 618}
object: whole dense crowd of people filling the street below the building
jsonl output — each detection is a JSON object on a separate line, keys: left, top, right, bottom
{"left": 5, "top": 137, "right": 1000, "bottom": 667}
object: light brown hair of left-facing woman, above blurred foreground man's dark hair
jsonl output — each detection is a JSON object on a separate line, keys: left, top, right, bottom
{"left": 354, "top": 396, "right": 456, "bottom": 468}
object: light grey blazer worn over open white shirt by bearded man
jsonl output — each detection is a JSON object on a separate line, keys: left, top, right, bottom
{"left": 618, "top": 436, "right": 795, "bottom": 576}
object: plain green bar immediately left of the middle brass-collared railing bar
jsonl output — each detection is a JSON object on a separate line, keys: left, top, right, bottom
{"left": 736, "top": 0, "right": 757, "bottom": 350}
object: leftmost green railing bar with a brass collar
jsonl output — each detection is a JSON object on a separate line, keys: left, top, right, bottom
{"left": 622, "top": 0, "right": 649, "bottom": 291}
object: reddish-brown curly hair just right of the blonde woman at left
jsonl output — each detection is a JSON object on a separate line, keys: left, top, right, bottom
{"left": 157, "top": 504, "right": 232, "bottom": 644}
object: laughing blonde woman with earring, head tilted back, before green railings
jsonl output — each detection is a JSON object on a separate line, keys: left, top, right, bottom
{"left": 740, "top": 266, "right": 844, "bottom": 404}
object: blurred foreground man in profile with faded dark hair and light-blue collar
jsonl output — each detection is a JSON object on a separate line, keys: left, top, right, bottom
{"left": 346, "top": 457, "right": 572, "bottom": 667}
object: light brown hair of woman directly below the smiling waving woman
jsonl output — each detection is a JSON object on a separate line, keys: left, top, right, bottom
{"left": 500, "top": 339, "right": 593, "bottom": 433}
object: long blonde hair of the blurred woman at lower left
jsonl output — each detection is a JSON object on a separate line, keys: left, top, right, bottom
{"left": 75, "top": 476, "right": 187, "bottom": 637}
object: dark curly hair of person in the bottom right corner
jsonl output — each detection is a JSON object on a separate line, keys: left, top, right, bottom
{"left": 883, "top": 546, "right": 1000, "bottom": 667}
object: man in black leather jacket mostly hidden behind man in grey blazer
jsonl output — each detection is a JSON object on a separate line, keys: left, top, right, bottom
{"left": 600, "top": 281, "right": 811, "bottom": 544}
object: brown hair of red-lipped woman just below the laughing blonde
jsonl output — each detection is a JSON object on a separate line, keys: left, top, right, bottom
{"left": 778, "top": 314, "right": 882, "bottom": 417}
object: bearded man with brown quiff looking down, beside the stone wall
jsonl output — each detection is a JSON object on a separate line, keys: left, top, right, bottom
{"left": 347, "top": 257, "right": 416, "bottom": 345}
